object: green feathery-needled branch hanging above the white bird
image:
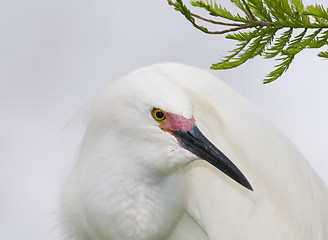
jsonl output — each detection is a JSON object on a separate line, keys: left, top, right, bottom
{"left": 168, "top": 0, "right": 328, "bottom": 83}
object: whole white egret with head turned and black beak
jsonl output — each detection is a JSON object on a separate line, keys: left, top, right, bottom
{"left": 61, "top": 63, "right": 328, "bottom": 240}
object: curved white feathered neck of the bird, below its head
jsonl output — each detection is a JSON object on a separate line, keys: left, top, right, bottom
{"left": 75, "top": 129, "right": 190, "bottom": 240}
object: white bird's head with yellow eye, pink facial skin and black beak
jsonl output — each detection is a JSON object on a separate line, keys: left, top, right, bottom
{"left": 87, "top": 69, "right": 252, "bottom": 189}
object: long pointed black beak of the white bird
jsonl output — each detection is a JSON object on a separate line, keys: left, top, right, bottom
{"left": 173, "top": 125, "right": 253, "bottom": 191}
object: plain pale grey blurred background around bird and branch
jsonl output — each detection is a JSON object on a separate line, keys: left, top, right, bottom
{"left": 0, "top": 0, "right": 328, "bottom": 240}
